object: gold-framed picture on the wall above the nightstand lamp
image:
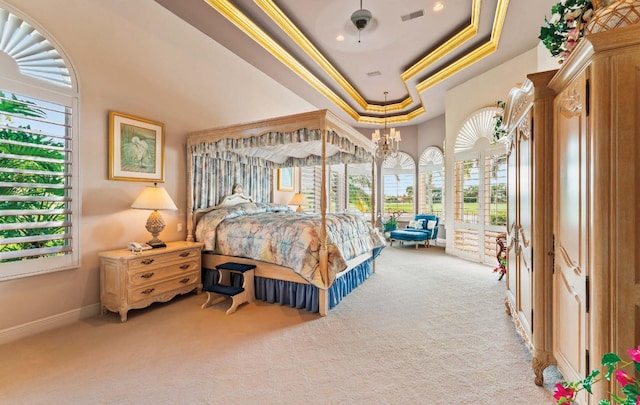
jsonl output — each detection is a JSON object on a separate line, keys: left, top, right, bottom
{"left": 109, "top": 111, "right": 164, "bottom": 182}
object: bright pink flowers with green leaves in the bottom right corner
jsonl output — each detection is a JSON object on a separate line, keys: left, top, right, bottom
{"left": 553, "top": 346, "right": 640, "bottom": 405}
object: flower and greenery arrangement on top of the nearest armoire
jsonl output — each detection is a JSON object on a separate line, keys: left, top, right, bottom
{"left": 538, "top": 0, "right": 593, "bottom": 63}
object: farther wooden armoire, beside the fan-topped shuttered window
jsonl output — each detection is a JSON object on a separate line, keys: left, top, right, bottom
{"left": 503, "top": 71, "right": 556, "bottom": 385}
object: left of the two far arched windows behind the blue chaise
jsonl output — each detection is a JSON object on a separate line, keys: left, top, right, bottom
{"left": 382, "top": 152, "right": 416, "bottom": 219}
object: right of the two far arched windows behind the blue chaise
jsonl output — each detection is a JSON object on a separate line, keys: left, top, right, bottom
{"left": 418, "top": 146, "right": 444, "bottom": 219}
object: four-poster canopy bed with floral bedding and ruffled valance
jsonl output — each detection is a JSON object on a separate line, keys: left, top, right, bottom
{"left": 187, "top": 110, "right": 384, "bottom": 315}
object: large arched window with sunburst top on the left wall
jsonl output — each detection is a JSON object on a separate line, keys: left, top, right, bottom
{"left": 0, "top": 3, "right": 80, "bottom": 280}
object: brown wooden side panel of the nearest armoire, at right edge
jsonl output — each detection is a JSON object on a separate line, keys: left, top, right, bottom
{"left": 607, "top": 51, "right": 640, "bottom": 358}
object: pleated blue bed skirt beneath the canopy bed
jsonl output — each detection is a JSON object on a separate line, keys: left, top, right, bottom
{"left": 254, "top": 249, "right": 382, "bottom": 312}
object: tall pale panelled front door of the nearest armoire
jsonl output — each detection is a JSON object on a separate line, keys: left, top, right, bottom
{"left": 553, "top": 72, "right": 589, "bottom": 381}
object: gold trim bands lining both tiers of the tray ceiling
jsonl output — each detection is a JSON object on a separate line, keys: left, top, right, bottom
{"left": 204, "top": 0, "right": 509, "bottom": 124}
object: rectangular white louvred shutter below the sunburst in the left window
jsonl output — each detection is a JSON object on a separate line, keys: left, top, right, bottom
{"left": 0, "top": 91, "right": 73, "bottom": 263}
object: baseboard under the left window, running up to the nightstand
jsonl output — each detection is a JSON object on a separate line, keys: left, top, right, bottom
{"left": 0, "top": 304, "right": 100, "bottom": 345}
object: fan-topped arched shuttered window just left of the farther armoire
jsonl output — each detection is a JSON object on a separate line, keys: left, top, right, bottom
{"left": 453, "top": 107, "right": 507, "bottom": 263}
